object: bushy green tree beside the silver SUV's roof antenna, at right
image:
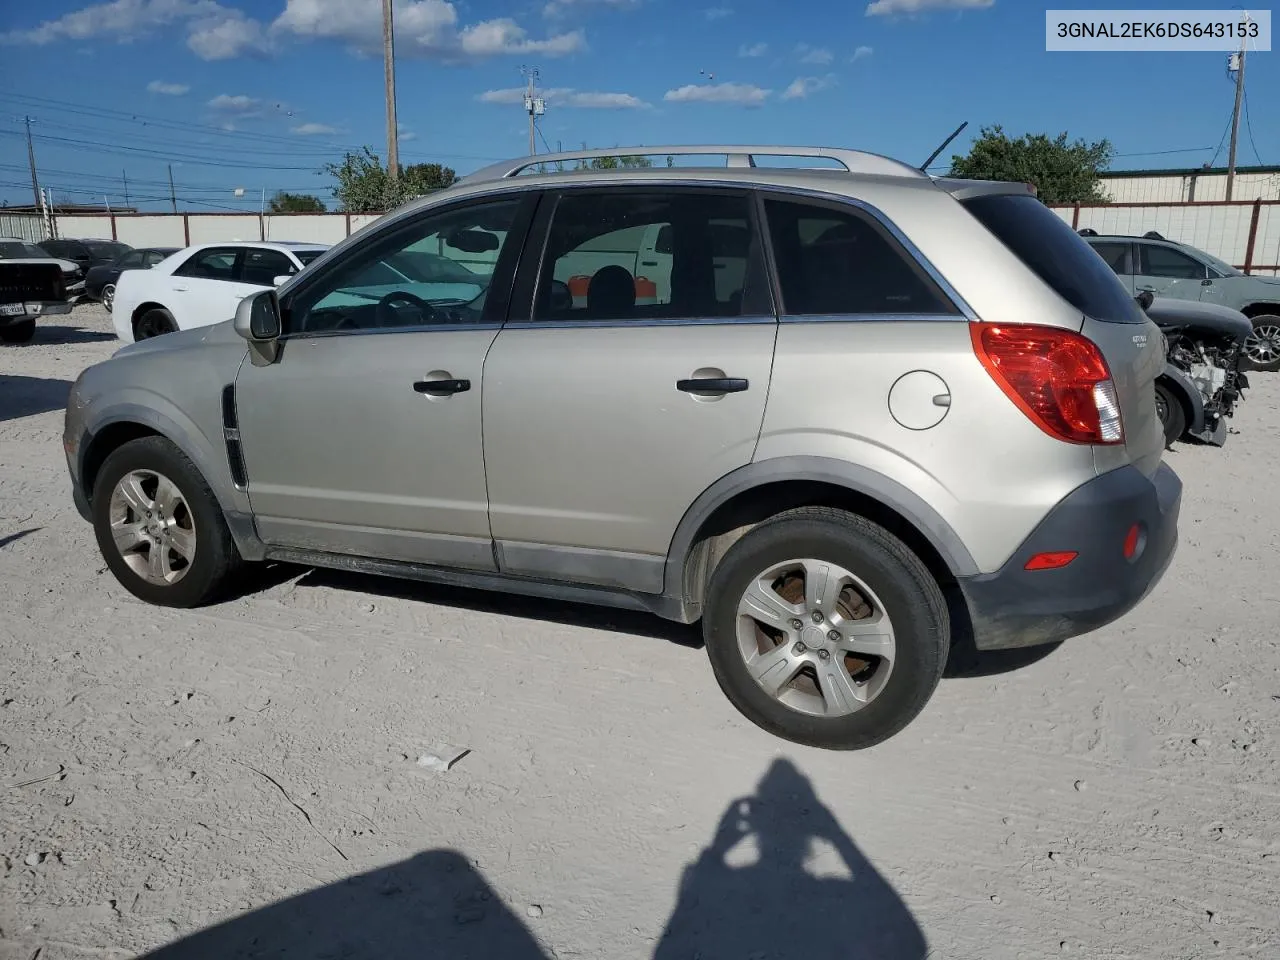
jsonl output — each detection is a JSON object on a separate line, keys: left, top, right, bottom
{"left": 951, "top": 124, "right": 1115, "bottom": 204}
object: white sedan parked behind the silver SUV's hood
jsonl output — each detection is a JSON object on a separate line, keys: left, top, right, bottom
{"left": 111, "top": 241, "right": 329, "bottom": 343}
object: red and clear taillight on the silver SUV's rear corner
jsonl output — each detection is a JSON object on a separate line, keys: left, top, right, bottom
{"left": 969, "top": 323, "right": 1124, "bottom": 444}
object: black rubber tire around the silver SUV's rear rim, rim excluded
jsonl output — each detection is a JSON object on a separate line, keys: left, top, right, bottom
{"left": 703, "top": 520, "right": 950, "bottom": 749}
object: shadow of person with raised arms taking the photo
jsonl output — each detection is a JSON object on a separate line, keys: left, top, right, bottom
{"left": 654, "top": 759, "right": 928, "bottom": 960}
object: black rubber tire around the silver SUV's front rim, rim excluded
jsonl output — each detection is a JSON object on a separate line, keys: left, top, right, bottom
{"left": 92, "top": 436, "right": 227, "bottom": 607}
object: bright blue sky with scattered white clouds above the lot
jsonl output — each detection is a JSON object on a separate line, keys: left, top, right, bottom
{"left": 0, "top": 0, "right": 1280, "bottom": 210}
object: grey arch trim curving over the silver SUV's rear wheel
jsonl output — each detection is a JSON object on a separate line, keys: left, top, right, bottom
{"left": 663, "top": 457, "right": 979, "bottom": 596}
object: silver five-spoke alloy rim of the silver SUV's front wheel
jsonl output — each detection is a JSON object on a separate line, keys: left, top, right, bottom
{"left": 108, "top": 470, "right": 196, "bottom": 586}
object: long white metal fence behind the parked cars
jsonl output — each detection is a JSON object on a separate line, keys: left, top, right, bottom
{"left": 37, "top": 200, "right": 1280, "bottom": 275}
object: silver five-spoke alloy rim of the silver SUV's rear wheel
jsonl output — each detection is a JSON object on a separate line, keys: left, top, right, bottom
{"left": 736, "top": 558, "right": 897, "bottom": 718}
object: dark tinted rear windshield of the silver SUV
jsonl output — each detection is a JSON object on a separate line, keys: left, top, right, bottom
{"left": 963, "top": 193, "right": 1147, "bottom": 324}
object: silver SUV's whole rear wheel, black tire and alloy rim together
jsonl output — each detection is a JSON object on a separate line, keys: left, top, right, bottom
{"left": 703, "top": 507, "right": 951, "bottom": 750}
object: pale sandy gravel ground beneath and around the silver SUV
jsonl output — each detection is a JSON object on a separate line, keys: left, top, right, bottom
{"left": 0, "top": 307, "right": 1280, "bottom": 960}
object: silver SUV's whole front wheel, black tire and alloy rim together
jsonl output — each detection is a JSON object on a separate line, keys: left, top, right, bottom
{"left": 92, "top": 436, "right": 239, "bottom": 607}
